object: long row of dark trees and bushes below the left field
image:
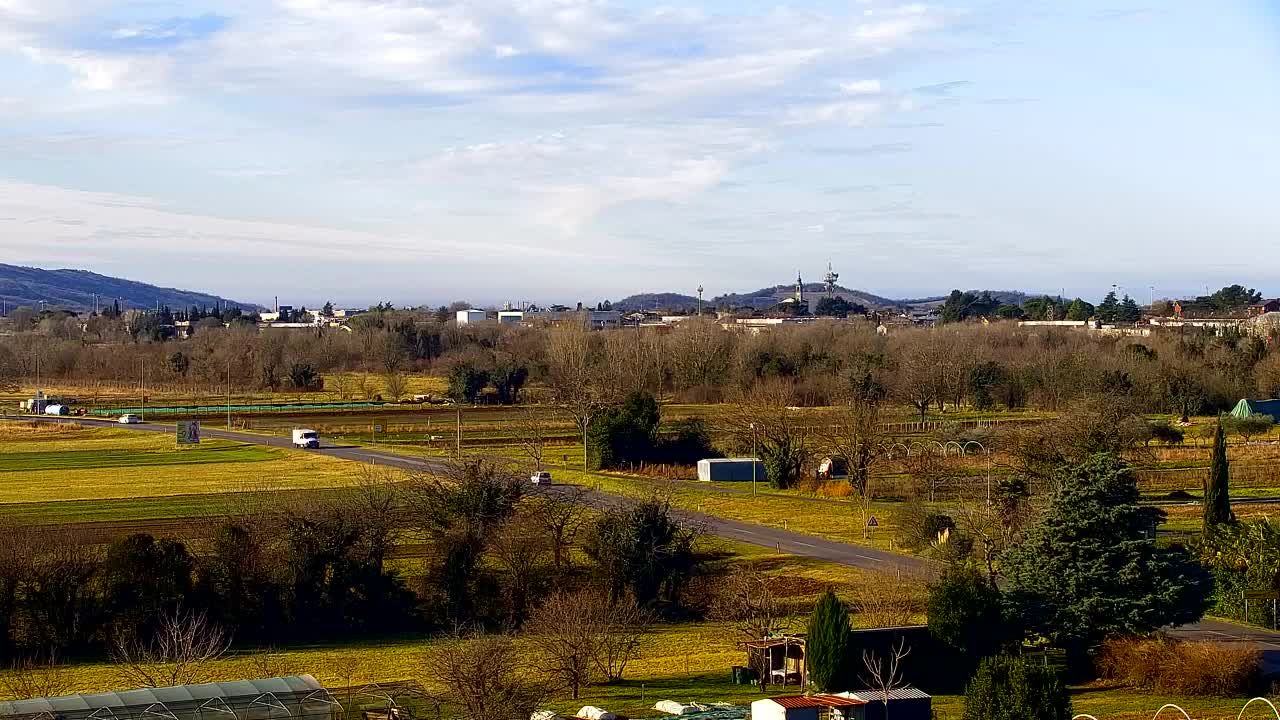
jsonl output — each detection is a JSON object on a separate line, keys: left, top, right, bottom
{"left": 0, "top": 459, "right": 700, "bottom": 687}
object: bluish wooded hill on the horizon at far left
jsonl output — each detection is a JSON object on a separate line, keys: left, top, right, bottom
{"left": 0, "top": 264, "right": 259, "bottom": 311}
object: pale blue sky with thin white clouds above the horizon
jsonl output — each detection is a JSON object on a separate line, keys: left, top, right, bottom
{"left": 0, "top": 0, "right": 1280, "bottom": 306}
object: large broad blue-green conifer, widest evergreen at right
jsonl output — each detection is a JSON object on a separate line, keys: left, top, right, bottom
{"left": 1001, "top": 454, "right": 1213, "bottom": 669}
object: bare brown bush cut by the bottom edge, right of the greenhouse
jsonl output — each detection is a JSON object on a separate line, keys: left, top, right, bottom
{"left": 426, "top": 633, "right": 547, "bottom": 720}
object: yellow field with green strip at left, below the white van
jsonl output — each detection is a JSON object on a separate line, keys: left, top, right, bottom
{"left": 0, "top": 423, "right": 373, "bottom": 503}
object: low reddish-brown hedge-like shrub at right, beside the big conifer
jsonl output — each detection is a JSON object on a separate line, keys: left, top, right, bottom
{"left": 1097, "top": 638, "right": 1262, "bottom": 697}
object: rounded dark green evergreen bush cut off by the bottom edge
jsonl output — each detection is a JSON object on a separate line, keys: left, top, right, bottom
{"left": 964, "top": 656, "right": 1071, "bottom": 720}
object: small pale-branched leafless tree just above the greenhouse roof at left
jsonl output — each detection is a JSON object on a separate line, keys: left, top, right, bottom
{"left": 111, "top": 609, "right": 230, "bottom": 688}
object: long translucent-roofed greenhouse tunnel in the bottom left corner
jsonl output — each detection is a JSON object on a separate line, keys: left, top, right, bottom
{"left": 0, "top": 675, "right": 342, "bottom": 720}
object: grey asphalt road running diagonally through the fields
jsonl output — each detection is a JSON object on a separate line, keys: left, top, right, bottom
{"left": 22, "top": 418, "right": 1280, "bottom": 653}
